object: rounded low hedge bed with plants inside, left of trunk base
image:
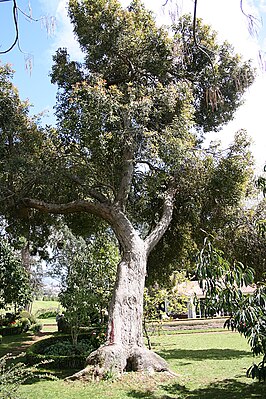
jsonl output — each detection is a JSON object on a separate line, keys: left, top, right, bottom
{"left": 26, "top": 332, "right": 103, "bottom": 369}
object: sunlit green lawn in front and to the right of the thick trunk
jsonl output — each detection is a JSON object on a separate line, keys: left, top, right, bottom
{"left": 16, "top": 332, "right": 266, "bottom": 399}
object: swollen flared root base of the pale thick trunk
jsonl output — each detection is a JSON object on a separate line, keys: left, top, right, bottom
{"left": 66, "top": 344, "right": 173, "bottom": 381}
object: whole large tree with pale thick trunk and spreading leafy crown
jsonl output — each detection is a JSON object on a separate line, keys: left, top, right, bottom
{"left": 1, "top": 0, "right": 254, "bottom": 375}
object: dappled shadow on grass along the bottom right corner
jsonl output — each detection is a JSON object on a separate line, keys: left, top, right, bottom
{"left": 128, "top": 379, "right": 266, "bottom": 399}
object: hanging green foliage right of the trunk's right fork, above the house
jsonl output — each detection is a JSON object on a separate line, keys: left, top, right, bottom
{"left": 148, "top": 131, "right": 255, "bottom": 284}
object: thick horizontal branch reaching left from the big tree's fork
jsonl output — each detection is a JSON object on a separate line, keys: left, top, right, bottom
{"left": 22, "top": 198, "right": 113, "bottom": 224}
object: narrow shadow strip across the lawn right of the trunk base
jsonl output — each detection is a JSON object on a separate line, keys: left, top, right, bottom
{"left": 157, "top": 349, "right": 250, "bottom": 364}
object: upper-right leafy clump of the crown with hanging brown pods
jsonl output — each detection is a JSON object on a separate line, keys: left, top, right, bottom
{"left": 173, "top": 15, "right": 254, "bottom": 132}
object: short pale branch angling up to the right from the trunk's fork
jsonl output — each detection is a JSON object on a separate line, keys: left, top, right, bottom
{"left": 145, "top": 184, "right": 177, "bottom": 253}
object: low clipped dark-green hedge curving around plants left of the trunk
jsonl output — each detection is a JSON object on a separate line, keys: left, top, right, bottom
{"left": 26, "top": 334, "right": 97, "bottom": 369}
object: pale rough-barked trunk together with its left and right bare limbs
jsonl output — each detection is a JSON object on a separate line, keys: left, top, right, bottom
{"left": 24, "top": 184, "right": 176, "bottom": 380}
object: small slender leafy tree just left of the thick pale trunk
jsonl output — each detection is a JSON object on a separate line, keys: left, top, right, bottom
{"left": 54, "top": 227, "right": 118, "bottom": 345}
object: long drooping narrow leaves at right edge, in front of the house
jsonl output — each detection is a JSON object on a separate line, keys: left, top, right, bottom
{"left": 196, "top": 239, "right": 266, "bottom": 380}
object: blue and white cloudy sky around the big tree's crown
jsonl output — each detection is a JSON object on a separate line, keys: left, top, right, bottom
{"left": 0, "top": 0, "right": 266, "bottom": 173}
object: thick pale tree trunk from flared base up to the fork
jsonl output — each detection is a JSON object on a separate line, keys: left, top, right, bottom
{"left": 67, "top": 237, "right": 169, "bottom": 379}
